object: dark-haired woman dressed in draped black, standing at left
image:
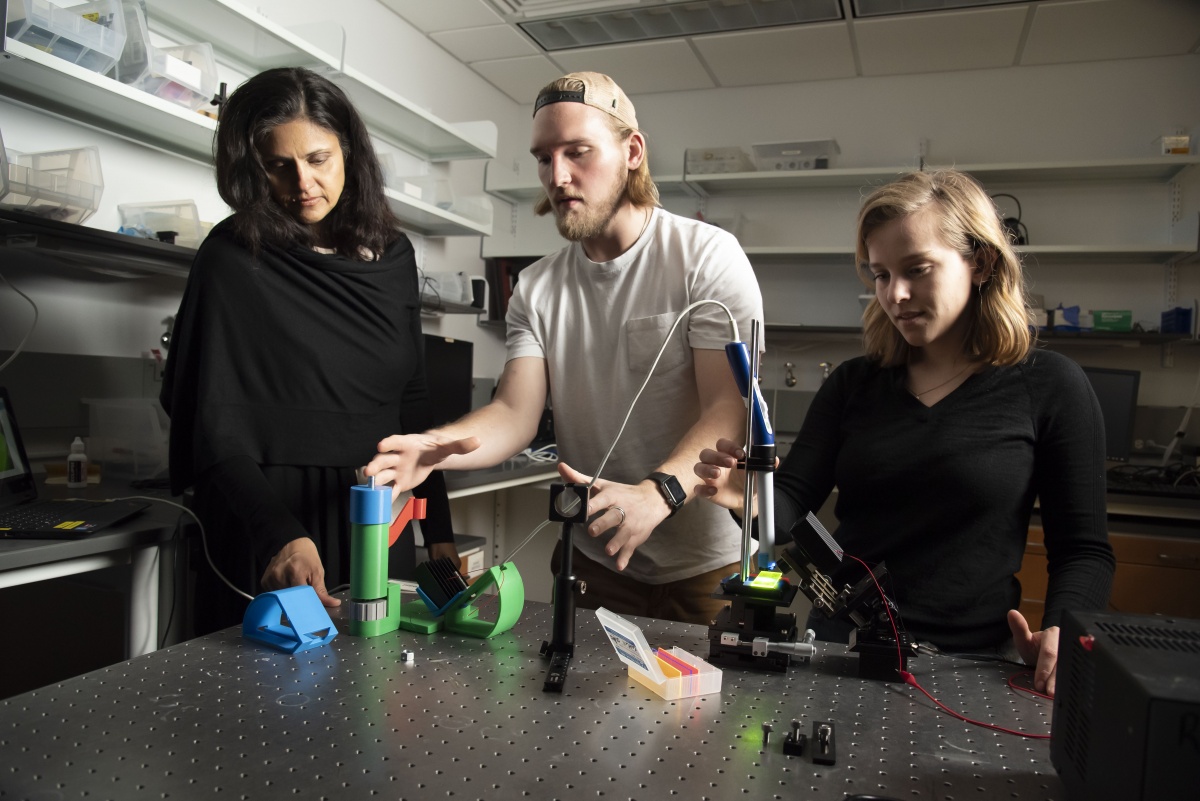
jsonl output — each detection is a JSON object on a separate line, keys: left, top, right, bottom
{"left": 162, "top": 67, "right": 458, "bottom": 634}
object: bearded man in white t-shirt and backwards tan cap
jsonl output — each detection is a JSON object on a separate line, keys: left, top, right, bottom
{"left": 366, "top": 72, "right": 762, "bottom": 625}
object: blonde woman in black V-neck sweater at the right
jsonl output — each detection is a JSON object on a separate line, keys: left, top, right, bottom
{"left": 695, "top": 170, "right": 1115, "bottom": 693}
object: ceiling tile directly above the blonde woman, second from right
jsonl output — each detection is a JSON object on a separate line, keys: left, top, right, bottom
{"left": 853, "top": 6, "right": 1028, "bottom": 76}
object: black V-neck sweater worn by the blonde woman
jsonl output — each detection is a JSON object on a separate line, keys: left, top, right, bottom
{"left": 775, "top": 350, "right": 1115, "bottom": 650}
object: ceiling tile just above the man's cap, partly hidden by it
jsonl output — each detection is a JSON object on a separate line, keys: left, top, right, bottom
{"left": 554, "top": 40, "right": 716, "bottom": 95}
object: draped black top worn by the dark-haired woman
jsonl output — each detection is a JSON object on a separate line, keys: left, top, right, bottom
{"left": 161, "top": 220, "right": 452, "bottom": 558}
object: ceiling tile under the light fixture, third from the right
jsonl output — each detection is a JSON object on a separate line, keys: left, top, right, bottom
{"left": 692, "top": 23, "right": 856, "bottom": 86}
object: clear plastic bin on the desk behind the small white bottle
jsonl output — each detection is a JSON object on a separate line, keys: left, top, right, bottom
{"left": 84, "top": 398, "right": 170, "bottom": 478}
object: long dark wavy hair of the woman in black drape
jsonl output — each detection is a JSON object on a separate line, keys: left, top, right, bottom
{"left": 214, "top": 67, "right": 400, "bottom": 260}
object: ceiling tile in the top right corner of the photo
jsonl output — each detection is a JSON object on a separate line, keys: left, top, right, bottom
{"left": 1021, "top": 0, "right": 1200, "bottom": 65}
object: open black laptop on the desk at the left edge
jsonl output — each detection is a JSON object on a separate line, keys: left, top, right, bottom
{"left": 0, "top": 387, "right": 150, "bottom": 540}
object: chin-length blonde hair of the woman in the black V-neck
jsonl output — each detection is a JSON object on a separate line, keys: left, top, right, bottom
{"left": 854, "top": 170, "right": 1034, "bottom": 366}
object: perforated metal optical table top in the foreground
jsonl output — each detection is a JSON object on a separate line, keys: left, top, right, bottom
{"left": 0, "top": 603, "right": 1063, "bottom": 801}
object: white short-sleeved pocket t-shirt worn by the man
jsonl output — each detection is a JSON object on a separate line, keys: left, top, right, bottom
{"left": 506, "top": 209, "right": 762, "bottom": 584}
